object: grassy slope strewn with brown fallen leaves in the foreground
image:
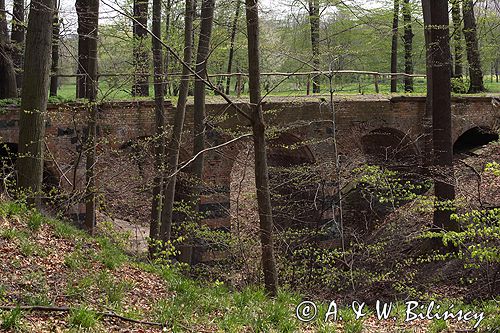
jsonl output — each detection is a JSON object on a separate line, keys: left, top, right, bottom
{"left": 0, "top": 197, "right": 500, "bottom": 333}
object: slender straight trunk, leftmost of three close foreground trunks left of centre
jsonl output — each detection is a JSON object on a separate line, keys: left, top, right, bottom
{"left": 149, "top": 0, "right": 165, "bottom": 249}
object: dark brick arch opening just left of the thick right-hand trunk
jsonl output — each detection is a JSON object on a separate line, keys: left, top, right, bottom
{"left": 361, "top": 127, "right": 420, "bottom": 165}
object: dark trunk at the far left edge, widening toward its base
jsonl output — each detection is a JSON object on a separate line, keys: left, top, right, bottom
{"left": 0, "top": 0, "right": 17, "bottom": 99}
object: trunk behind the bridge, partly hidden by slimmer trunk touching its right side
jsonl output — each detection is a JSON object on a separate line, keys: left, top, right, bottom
{"left": 75, "top": 0, "right": 92, "bottom": 98}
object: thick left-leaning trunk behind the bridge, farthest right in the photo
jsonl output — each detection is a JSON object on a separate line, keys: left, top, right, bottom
{"left": 462, "top": 0, "right": 485, "bottom": 94}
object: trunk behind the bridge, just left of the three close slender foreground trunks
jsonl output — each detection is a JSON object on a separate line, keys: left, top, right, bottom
{"left": 132, "top": 0, "right": 149, "bottom": 96}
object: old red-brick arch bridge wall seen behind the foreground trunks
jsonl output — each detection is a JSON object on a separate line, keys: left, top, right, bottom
{"left": 0, "top": 96, "right": 500, "bottom": 228}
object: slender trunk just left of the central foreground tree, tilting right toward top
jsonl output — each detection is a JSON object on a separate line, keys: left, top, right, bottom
{"left": 193, "top": 0, "right": 215, "bottom": 197}
